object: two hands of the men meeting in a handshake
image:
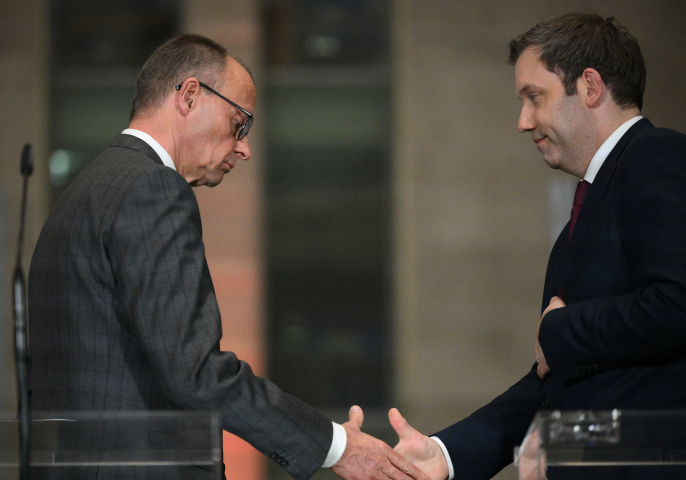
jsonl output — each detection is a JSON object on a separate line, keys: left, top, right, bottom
{"left": 331, "top": 406, "right": 448, "bottom": 480}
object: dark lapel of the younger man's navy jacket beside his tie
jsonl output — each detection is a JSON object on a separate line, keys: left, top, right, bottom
{"left": 544, "top": 118, "right": 655, "bottom": 303}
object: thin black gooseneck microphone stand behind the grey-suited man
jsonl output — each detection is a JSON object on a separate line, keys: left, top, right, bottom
{"left": 13, "top": 143, "right": 33, "bottom": 480}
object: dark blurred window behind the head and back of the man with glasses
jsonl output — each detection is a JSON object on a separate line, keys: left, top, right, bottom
{"left": 49, "top": 0, "right": 180, "bottom": 201}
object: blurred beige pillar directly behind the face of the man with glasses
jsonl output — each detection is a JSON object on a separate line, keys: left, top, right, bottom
{"left": 183, "top": 0, "right": 266, "bottom": 480}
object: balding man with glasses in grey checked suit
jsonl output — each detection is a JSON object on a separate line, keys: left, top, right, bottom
{"left": 29, "top": 35, "right": 427, "bottom": 480}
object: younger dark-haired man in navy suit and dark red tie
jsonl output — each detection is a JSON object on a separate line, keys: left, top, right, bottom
{"left": 389, "top": 13, "right": 686, "bottom": 480}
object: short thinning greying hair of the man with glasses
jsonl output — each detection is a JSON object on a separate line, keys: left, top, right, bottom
{"left": 131, "top": 34, "right": 229, "bottom": 119}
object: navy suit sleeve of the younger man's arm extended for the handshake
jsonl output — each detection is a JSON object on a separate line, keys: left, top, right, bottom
{"left": 435, "top": 364, "right": 541, "bottom": 480}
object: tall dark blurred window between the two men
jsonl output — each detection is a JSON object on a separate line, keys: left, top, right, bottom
{"left": 264, "top": 0, "right": 392, "bottom": 416}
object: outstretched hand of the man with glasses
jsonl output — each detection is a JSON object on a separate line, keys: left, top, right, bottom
{"left": 331, "top": 405, "right": 431, "bottom": 480}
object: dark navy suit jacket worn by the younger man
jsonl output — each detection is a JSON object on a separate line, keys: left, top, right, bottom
{"left": 437, "top": 119, "right": 686, "bottom": 479}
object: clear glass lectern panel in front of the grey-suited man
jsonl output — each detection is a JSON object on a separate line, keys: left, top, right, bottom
{"left": 0, "top": 411, "right": 222, "bottom": 473}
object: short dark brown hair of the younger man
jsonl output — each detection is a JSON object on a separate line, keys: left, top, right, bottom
{"left": 507, "top": 12, "right": 646, "bottom": 110}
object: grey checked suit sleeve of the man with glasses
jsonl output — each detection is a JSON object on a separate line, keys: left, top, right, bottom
{"left": 105, "top": 168, "right": 333, "bottom": 479}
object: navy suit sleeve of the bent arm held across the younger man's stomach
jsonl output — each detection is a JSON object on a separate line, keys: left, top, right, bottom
{"left": 539, "top": 130, "right": 686, "bottom": 380}
